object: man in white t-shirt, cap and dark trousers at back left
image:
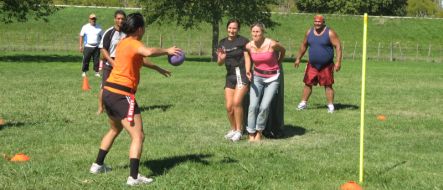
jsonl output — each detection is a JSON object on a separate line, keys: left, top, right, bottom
{"left": 79, "top": 14, "right": 102, "bottom": 77}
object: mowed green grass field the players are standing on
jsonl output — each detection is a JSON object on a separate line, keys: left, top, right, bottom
{"left": 0, "top": 52, "right": 443, "bottom": 190}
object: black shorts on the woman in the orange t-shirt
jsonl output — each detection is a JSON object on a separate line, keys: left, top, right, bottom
{"left": 103, "top": 89, "right": 140, "bottom": 120}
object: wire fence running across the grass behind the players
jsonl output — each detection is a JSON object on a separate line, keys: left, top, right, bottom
{"left": 0, "top": 33, "right": 443, "bottom": 63}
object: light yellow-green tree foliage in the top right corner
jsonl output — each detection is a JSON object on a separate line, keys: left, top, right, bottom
{"left": 407, "top": 0, "right": 438, "bottom": 17}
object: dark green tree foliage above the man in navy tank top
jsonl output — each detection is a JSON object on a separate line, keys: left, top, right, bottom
{"left": 295, "top": 0, "right": 407, "bottom": 16}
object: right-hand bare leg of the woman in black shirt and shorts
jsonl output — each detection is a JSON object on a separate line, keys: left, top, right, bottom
{"left": 233, "top": 85, "right": 249, "bottom": 132}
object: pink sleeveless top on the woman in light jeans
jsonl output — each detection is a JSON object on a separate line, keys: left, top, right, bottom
{"left": 250, "top": 38, "right": 280, "bottom": 78}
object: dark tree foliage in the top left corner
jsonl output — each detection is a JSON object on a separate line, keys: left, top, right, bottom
{"left": 0, "top": 0, "right": 57, "bottom": 23}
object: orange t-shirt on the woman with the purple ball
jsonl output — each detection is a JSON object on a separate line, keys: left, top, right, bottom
{"left": 104, "top": 38, "right": 143, "bottom": 96}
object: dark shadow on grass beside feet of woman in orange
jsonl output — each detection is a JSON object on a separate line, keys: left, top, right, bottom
{"left": 140, "top": 154, "right": 213, "bottom": 177}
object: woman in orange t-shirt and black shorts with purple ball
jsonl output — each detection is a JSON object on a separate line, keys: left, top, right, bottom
{"left": 90, "top": 13, "right": 181, "bottom": 186}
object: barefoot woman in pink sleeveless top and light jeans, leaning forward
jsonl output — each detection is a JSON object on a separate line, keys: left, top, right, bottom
{"left": 246, "top": 23, "right": 286, "bottom": 141}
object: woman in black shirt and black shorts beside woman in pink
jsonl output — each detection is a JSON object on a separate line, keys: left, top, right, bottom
{"left": 217, "top": 19, "right": 251, "bottom": 142}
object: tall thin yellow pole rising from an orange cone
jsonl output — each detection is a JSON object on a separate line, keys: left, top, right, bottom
{"left": 359, "top": 13, "right": 368, "bottom": 183}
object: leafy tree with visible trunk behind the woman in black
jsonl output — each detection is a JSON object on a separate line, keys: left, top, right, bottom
{"left": 140, "top": 0, "right": 277, "bottom": 60}
